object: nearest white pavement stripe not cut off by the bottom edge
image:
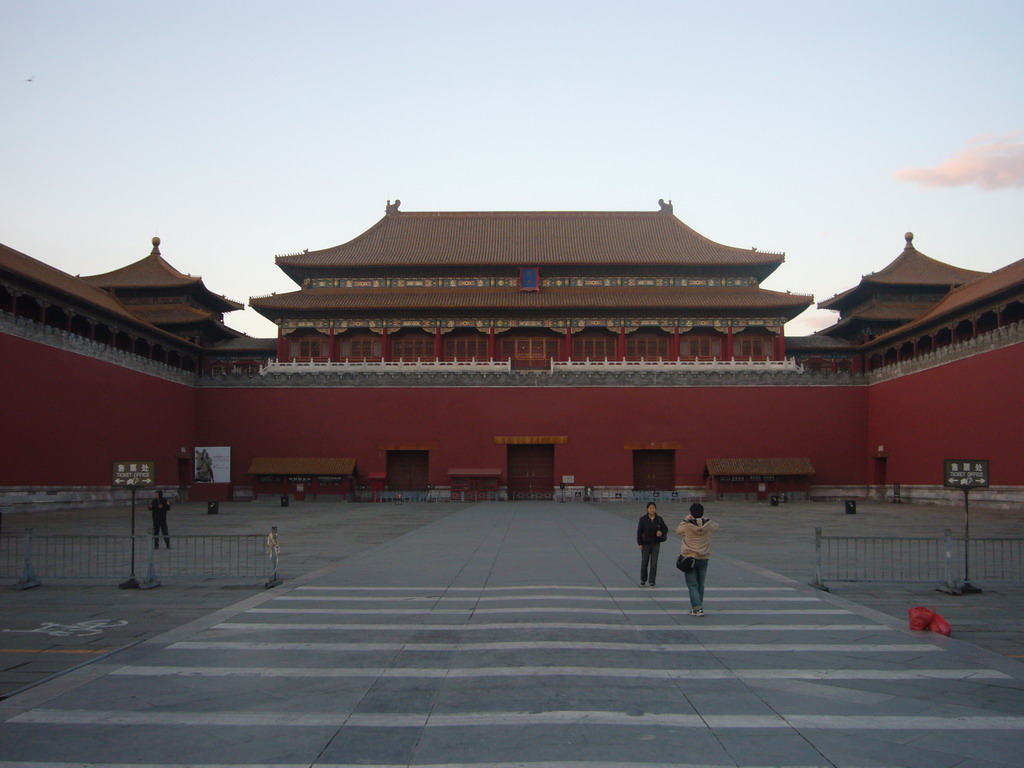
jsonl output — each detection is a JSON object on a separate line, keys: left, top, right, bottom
{"left": 14, "top": 709, "right": 1024, "bottom": 731}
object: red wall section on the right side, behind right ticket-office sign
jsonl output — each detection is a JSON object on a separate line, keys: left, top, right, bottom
{"left": 867, "top": 344, "right": 1024, "bottom": 485}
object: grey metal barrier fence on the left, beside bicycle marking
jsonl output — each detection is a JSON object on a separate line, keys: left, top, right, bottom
{"left": 0, "top": 530, "right": 280, "bottom": 588}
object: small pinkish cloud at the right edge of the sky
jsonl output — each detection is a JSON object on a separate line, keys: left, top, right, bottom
{"left": 895, "top": 133, "right": 1024, "bottom": 189}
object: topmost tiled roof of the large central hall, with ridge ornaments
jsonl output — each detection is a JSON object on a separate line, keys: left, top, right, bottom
{"left": 276, "top": 211, "right": 785, "bottom": 279}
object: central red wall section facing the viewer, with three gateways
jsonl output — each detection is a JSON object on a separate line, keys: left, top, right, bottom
{"left": 198, "top": 386, "right": 867, "bottom": 485}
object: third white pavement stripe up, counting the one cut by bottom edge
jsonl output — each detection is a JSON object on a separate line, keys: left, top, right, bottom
{"left": 111, "top": 666, "right": 1010, "bottom": 680}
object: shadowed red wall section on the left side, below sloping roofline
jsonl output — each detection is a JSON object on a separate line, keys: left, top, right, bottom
{"left": 0, "top": 333, "right": 197, "bottom": 486}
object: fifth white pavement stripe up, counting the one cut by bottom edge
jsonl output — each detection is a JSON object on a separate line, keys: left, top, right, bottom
{"left": 211, "top": 622, "right": 893, "bottom": 632}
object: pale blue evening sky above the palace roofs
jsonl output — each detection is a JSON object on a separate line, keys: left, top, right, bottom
{"left": 0, "top": 0, "right": 1024, "bottom": 337}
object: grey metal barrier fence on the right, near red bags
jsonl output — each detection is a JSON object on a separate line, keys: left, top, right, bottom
{"left": 812, "top": 528, "right": 1024, "bottom": 591}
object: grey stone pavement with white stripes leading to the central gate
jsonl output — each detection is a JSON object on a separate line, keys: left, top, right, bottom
{"left": 0, "top": 503, "right": 1024, "bottom": 768}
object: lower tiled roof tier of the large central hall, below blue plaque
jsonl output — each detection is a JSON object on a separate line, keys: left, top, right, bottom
{"left": 250, "top": 287, "right": 814, "bottom": 313}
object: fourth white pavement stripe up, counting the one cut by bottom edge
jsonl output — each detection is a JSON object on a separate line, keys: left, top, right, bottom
{"left": 174, "top": 640, "right": 943, "bottom": 654}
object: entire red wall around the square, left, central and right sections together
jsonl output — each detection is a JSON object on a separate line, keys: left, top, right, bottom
{"left": 0, "top": 333, "right": 1024, "bottom": 486}
